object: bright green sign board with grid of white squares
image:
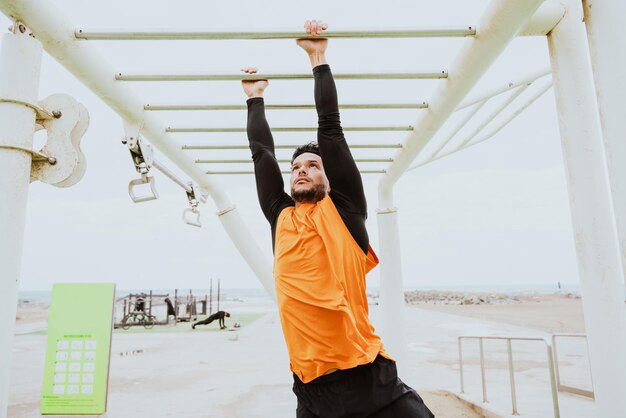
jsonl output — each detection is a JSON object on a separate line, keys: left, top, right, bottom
{"left": 41, "top": 283, "right": 115, "bottom": 415}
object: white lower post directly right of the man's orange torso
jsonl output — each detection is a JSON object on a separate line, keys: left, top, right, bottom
{"left": 378, "top": 202, "right": 406, "bottom": 373}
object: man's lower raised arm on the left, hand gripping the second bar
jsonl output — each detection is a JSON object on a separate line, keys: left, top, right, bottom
{"left": 242, "top": 68, "right": 293, "bottom": 225}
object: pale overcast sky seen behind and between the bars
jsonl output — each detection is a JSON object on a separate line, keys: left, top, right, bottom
{"left": 4, "top": 0, "right": 578, "bottom": 290}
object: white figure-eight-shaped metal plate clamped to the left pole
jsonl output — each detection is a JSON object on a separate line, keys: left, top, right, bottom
{"left": 30, "top": 94, "right": 89, "bottom": 187}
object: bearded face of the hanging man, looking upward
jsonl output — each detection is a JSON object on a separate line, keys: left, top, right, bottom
{"left": 290, "top": 152, "right": 330, "bottom": 203}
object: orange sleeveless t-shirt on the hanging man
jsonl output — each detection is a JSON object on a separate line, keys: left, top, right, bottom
{"left": 274, "top": 196, "right": 389, "bottom": 383}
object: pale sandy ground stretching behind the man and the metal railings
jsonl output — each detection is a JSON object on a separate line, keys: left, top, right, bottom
{"left": 9, "top": 295, "right": 593, "bottom": 418}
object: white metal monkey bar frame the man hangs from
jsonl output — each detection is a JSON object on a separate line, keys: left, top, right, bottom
{"left": 0, "top": 0, "right": 626, "bottom": 416}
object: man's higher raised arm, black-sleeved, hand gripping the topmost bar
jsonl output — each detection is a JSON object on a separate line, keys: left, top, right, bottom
{"left": 297, "top": 20, "right": 367, "bottom": 216}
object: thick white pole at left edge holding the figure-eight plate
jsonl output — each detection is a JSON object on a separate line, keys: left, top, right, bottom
{"left": 0, "top": 28, "right": 42, "bottom": 418}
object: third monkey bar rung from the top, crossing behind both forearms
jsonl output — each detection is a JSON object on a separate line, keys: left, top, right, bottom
{"left": 143, "top": 102, "right": 428, "bottom": 111}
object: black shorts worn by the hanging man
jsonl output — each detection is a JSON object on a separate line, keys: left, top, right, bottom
{"left": 293, "top": 355, "right": 434, "bottom": 418}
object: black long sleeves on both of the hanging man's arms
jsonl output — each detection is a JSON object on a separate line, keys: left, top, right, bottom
{"left": 247, "top": 64, "right": 369, "bottom": 253}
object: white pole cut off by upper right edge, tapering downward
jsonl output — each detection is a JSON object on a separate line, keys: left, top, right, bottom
{"left": 583, "top": 0, "right": 626, "bottom": 276}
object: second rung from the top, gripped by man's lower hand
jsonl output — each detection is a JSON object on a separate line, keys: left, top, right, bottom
{"left": 115, "top": 70, "right": 448, "bottom": 81}
